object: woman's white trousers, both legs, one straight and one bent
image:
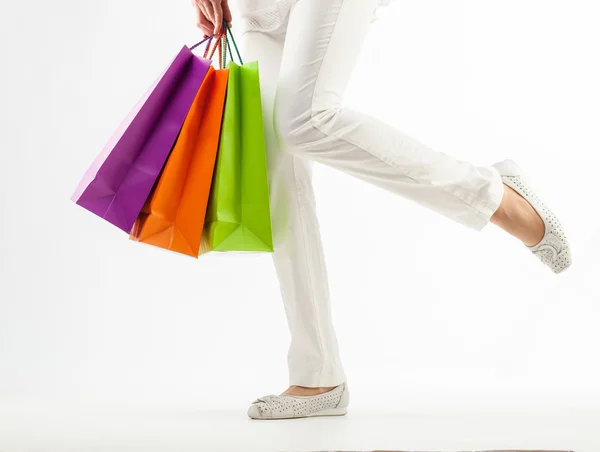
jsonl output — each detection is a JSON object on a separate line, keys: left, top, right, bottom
{"left": 234, "top": 0, "right": 504, "bottom": 387}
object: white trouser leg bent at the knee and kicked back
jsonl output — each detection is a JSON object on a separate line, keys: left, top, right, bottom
{"left": 274, "top": 0, "right": 504, "bottom": 230}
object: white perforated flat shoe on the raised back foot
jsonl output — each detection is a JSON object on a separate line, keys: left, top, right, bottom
{"left": 492, "top": 160, "right": 571, "bottom": 273}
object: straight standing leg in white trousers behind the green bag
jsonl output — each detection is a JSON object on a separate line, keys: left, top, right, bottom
{"left": 241, "top": 0, "right": 346, "bottom": 395}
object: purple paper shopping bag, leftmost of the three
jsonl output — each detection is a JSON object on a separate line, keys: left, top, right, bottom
{"left": 71, "top": 37, "right": 211, "bottom": 233}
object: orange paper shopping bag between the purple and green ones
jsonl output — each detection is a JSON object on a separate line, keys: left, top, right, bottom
{"left": 130, "top": 40, "right": 229, "bottom": 259}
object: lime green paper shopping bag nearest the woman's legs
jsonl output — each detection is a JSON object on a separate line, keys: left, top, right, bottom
{"left": 200, "top": 24, "right": 273, "bottom": 254}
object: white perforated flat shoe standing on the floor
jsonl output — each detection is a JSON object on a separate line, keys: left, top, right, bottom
{"left": 248, "top": 383, "right": 350, "bottom": 420}
